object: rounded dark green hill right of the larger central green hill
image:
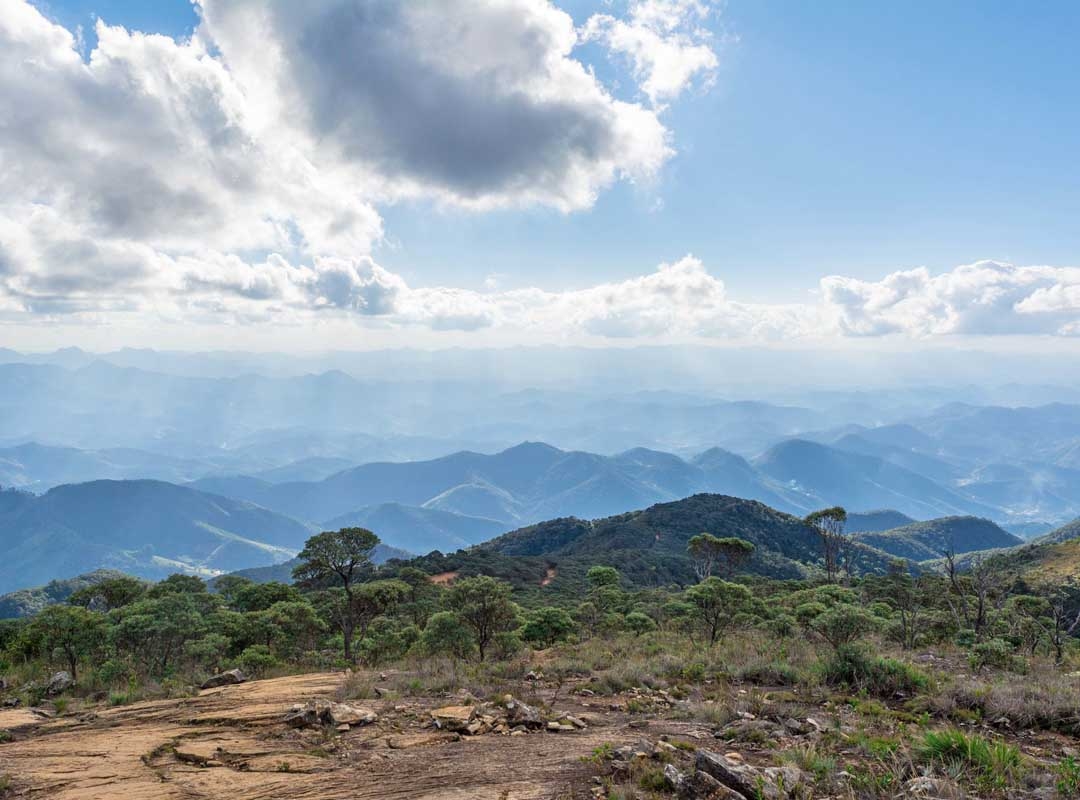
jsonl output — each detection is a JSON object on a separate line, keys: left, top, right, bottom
{"left": 854, "top": 516, "right": 1024, "bottom": 561}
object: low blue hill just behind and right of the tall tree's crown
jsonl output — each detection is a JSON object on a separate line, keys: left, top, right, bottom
{"left": 321, "top": 503, "right": 509, "bottom": 555}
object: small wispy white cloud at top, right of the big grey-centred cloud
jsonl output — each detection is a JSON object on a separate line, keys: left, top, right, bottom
{"left": 582, "top": 0, "right": 719, "bottom": 107}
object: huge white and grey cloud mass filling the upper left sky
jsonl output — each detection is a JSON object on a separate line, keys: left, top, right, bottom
{"left": 0, "top": 0, "right": 695, "bottom": 328}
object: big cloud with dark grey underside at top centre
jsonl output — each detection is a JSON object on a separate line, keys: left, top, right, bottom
{"left": 199, "top": 0, "right": 672, "bottom": 211}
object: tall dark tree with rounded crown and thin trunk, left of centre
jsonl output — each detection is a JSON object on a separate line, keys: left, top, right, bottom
{"left": 293, "top": 528, "right": 379, "bottom": 661}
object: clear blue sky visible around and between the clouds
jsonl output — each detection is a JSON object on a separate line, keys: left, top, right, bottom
{"left": 31, "top": 0, "right": 1080, "bottom": 300}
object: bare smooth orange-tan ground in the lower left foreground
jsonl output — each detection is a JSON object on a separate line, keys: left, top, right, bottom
{"left": 0, "top": 674, "right": 640, "bottom": 800}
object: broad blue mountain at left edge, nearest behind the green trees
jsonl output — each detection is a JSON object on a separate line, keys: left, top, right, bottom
{"left": 0, "top": 480, "right": 312, "bottom": 591}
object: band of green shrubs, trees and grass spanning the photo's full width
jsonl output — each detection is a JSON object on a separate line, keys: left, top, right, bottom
{"left": 0, "top": 510, "right": 1080, "bottom": 797}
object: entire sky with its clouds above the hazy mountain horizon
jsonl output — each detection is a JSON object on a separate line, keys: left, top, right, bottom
{"left": 0, "top": 0, "right": 1080, "bottom": 352}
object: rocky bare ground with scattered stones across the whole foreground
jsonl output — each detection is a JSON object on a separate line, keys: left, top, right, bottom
{"left": 0, "top": 673, "right": 1077, "bottom": 800}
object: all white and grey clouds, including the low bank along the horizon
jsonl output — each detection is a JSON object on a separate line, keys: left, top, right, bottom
{"left": 0, "top": 0, "right": 1080, "bottom": 341}
